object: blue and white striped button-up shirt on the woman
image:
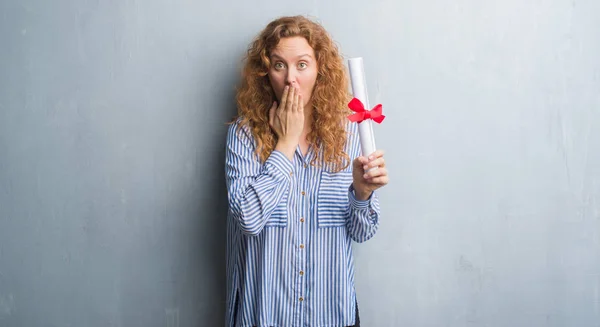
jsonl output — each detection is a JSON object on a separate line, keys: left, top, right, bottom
{"left": 225, "top": 120, "right": 379, "bottom": 327}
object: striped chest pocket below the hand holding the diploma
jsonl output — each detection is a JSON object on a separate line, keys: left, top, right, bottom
{"left": 317, "top": 170, "right": 352, "bottom": 228}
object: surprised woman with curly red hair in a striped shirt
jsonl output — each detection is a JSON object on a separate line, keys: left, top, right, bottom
{"left": 225, "top": 16, "right": 388, "bottom": 327}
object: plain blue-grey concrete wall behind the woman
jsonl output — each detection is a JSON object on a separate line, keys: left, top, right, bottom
{"left": 0, "top": 0, "right": 600, "bottom": 327}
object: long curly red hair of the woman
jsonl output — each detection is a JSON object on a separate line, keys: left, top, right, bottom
{"left": 231, "top": 16, "right": 350, "bottom": 170}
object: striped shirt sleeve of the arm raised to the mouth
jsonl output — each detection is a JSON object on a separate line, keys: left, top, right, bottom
{"left": 225, "top": 124, "right": 293, "bottom": 235}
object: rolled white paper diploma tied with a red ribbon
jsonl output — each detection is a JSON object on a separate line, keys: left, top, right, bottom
{"left": 348, "top": 57, "right": 376, "bottom": 163}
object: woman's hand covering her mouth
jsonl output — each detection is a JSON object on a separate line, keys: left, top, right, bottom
{"left": 269, "top": 86, "right": 304, "bottom": 160}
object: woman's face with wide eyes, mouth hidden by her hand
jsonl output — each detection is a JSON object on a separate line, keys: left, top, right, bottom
{"left": 269, "top": 36, "right": 318, "bottom": 107}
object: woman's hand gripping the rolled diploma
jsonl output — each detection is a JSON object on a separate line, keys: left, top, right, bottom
{"left": 352, "top": 150, "right": 389, "bottom": 200}
